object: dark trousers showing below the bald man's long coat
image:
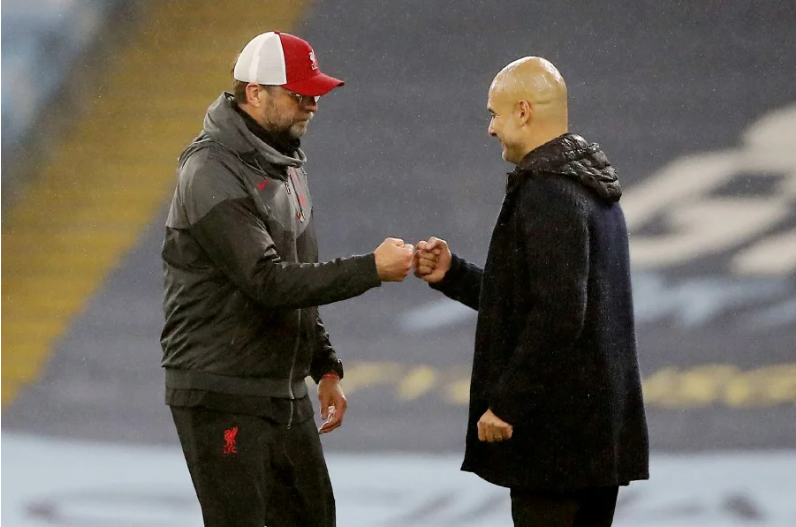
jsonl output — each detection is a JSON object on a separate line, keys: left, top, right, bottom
{"left": 511, "top": 487, "right": 619, "bottom": 527}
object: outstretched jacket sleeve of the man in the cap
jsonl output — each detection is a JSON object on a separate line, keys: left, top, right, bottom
{"left": 183, "top": 159, "right": 381, "bottom": 309}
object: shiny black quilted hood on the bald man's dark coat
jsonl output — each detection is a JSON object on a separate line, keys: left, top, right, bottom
{"left": 509, "top": 134, "right": 622, "bottom": 202}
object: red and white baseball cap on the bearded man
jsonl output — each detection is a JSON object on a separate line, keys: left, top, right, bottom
{"left": 233, "top": 31, "right": 345, "bottom": 97}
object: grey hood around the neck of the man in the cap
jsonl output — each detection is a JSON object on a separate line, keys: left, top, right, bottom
{"left": 180, "top": 92, "right": 307, "bottom": 168}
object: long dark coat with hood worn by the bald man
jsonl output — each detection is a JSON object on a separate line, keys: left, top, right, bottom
{"left": 432, "top": 134, "right": 649, "bottom": 490}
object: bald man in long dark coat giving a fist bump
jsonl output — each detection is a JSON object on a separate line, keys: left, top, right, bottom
{"left": 415, "top": 57, "right": 649, "bottom": 527}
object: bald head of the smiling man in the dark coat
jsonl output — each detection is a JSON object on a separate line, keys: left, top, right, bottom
{"left": 488, "top": 57, "right": 567, "bottom": 163}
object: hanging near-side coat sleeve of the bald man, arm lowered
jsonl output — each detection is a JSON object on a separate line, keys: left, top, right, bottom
{"left": 488, "top": 182, "right": 589, "bottom": 425}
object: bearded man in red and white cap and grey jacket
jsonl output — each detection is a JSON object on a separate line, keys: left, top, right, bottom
{"left": 161, "top": 32, "right": 413, "bottom": 527}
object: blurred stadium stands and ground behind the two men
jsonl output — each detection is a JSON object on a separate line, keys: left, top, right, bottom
{"left": 2, "top": 0, "right": 796, "bottom": 527}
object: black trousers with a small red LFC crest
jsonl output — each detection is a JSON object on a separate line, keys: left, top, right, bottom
{"left": 171, "top": 407, "right": 335, "bottom": 527}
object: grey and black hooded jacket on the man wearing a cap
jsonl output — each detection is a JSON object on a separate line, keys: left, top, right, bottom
{"left": 161, "top": 93, "right": 381, "bottom": 399}
